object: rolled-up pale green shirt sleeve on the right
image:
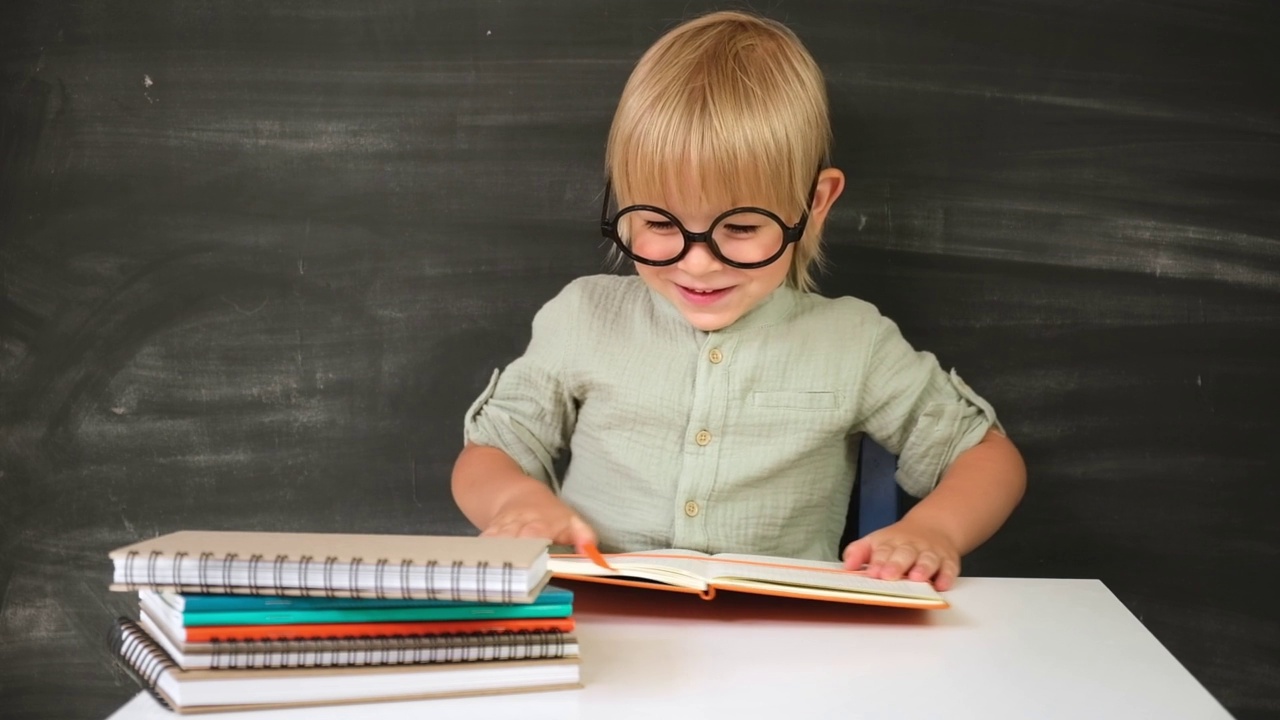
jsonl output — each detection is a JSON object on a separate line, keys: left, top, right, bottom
{"left": 860, "top": 318, "right": 1004, "bottom": 497}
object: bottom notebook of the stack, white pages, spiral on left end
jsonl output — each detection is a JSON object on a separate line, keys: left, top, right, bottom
{"left": 110, "top": 618, "right": 581, "bottom": 714}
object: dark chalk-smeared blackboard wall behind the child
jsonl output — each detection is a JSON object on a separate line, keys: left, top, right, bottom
{"left": 0, "top": 0, "right": 1280, "bottom": 719}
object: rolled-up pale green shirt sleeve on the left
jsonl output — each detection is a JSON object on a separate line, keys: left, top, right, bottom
{"left": 462, "top": 286, "right": 576, "bottom": 491}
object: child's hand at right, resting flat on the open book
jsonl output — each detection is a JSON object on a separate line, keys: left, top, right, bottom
{"left": 845, "top": 518, "right": 960, "bottom": 591}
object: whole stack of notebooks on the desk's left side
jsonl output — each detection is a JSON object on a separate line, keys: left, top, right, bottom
{"left": 111, "top": 532, "right": 580, "bottom": 712}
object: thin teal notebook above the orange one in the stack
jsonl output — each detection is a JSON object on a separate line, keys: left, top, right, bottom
{"left": 138, "top": 588, "right": 573, "bottom": 628}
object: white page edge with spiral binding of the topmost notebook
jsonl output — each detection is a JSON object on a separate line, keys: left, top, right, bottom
{"left": 113, "top": 551, "right": 529, "bottom": 603}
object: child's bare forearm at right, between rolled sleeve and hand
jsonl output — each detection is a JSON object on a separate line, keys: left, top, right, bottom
{"left": 904, "top": 430, "right": 1027, "bottom": 555}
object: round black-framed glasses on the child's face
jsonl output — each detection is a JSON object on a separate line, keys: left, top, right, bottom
{"left": 600, "top": 179, "right": 817, "bottom": 269}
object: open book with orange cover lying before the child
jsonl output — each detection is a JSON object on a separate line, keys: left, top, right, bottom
{"left": 548, "top": 550, "right": 948, "bottom": 610}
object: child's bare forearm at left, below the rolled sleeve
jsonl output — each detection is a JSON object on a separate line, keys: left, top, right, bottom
{"left": 452, "top": 443, "right": 559, "bottom": 529}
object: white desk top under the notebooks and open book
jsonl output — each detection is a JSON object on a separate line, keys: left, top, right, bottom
{"left": 111, "top": 578, "right": 1230, "bottom": 720}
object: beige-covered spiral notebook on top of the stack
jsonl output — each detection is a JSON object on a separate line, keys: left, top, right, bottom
{"left": 110, "top": 530, "right": 550, "bottom": 603}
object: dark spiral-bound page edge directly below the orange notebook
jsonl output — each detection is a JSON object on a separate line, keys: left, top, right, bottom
{"left": 202, "top": 632, "right": 568, "bottom": 670}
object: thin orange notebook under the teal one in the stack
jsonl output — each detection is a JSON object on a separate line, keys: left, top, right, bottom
{"left": 146, "top": 618, "right": 573, "bottom": 643}
